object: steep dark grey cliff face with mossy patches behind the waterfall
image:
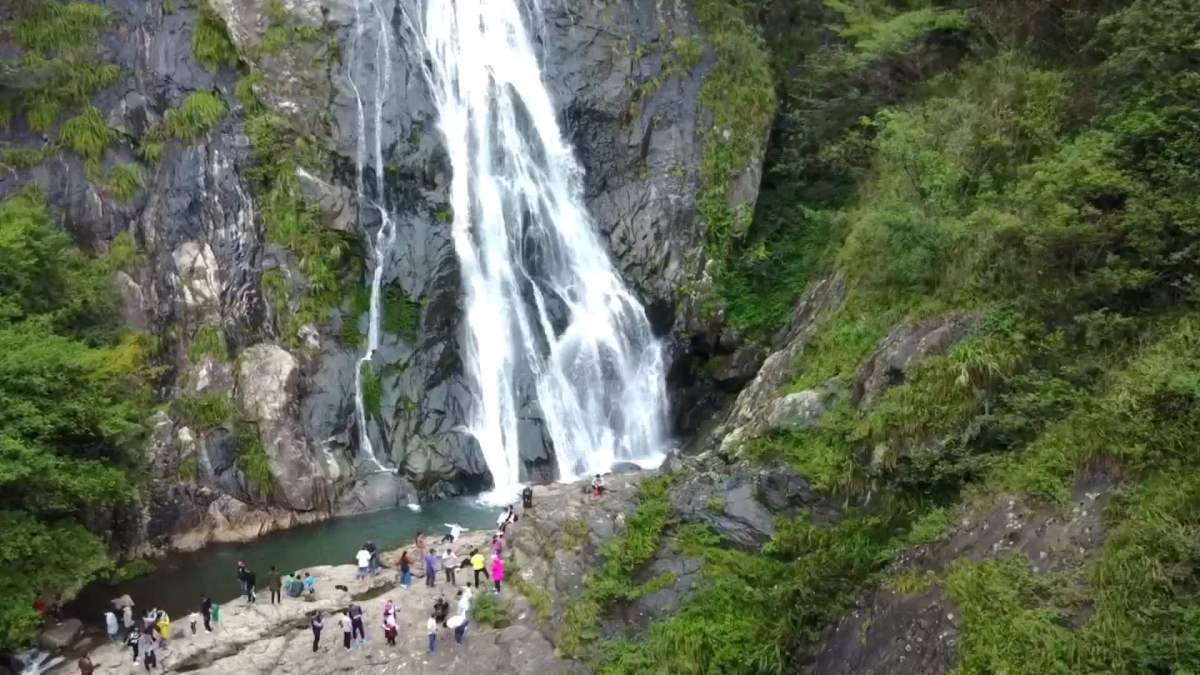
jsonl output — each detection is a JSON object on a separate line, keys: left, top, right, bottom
{"left": 0, "top": 0, "right": 762, "bottom": 552}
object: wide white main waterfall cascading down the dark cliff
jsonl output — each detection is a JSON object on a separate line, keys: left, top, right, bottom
{"left": 422, "top": 0, "right": 667, "bottom": 498}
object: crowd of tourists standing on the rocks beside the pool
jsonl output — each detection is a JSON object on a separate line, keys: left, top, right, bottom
{"left": 79, "top": 488, "right": 544, "bottom": 675}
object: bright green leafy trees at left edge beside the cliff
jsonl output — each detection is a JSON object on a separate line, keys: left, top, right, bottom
{"left": 0, "top": 191, "right": 155, "bottom": 651}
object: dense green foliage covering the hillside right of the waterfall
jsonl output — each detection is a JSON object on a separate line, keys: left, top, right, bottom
{"left": 595, "top": 0, "right": 1200, "bottom": 673}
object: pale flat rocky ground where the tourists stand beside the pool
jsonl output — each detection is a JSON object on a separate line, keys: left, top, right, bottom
{"left": 50, "top": 472, "right": 644, "bottom": 675}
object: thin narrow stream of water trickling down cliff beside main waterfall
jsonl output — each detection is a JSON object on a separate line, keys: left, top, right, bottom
{"left": 347, "top": 0, "right": 396, "bottom": 471}
